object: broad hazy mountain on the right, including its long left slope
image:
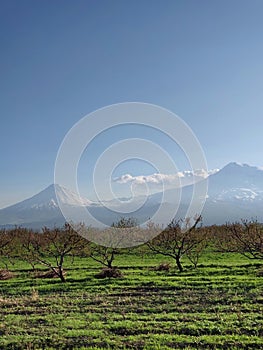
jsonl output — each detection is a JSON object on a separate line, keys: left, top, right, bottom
{"left": 120, "top": 162, "right": 263, "bottom": 225}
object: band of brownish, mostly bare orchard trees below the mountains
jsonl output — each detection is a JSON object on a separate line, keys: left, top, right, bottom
{"left": 0, "top": 217, "right": 263, "bottom": 282}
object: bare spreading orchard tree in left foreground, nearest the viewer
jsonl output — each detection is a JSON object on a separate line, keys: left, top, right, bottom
{"left": 18, "top": 223, "right": 89, "bottom": 282}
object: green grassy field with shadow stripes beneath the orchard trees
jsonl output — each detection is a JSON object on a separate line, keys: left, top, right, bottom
{"left": 0, "top": 250, "right": 263, "bottom": 349}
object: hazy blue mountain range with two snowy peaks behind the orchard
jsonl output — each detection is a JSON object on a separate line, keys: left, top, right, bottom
{"left": 0, "top": 163, "right": 263, "bottom": 229}
